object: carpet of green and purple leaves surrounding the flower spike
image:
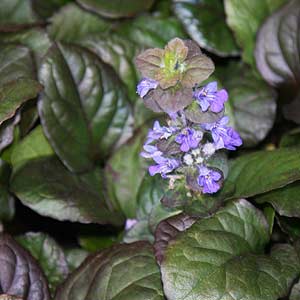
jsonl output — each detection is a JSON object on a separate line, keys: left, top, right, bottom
{"left": 0, "top": 0, "right": 300, "bottom": 300}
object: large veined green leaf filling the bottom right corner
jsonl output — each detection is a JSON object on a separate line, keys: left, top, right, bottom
{"left": 161, "top": 200, "right": 300, "bottom": 300}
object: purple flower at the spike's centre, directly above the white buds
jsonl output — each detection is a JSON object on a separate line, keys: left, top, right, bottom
{"left": 175, "top": 127, "right": 203, "bottom": 152}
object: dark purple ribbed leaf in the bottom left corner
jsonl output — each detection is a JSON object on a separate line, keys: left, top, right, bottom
{"left": 0, "top": 234, "right": 50, "bottom": 300}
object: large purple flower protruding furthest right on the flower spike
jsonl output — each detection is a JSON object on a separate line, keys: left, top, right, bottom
{"left": 202, "top": 116, "right": 243, "bottom": 150}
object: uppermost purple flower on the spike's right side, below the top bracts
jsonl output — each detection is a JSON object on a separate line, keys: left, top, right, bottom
{"left": 194, "top": 81, "right": 228, "bottom": 113}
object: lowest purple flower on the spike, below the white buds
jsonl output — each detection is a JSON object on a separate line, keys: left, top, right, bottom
{"left": 197, "top": 166, "right": 222, "bottom": 194}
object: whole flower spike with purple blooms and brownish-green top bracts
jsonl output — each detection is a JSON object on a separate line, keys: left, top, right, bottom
{"left": 136, "top": 38, "right": 242, "bottom": 197}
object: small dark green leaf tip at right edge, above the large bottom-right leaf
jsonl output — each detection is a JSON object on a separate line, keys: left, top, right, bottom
{"left": 255, "top": 181, "right": 300, "bottom": 218}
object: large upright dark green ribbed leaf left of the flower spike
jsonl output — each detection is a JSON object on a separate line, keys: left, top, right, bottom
{"left": 39, "top": 45, "right": 129, "bottom": 172}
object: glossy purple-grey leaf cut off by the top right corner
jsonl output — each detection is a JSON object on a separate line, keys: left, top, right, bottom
{"left": 255, "top": 0, "right": 300, "bottom": 88}
